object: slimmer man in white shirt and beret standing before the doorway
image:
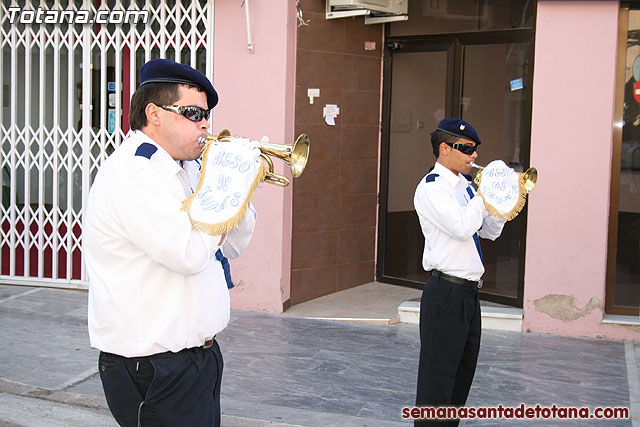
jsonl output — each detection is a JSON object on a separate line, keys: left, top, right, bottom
{"left": 414, "top": 118, "right": 505, "bottom": 425}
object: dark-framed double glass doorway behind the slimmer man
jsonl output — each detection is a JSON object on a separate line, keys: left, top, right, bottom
{"left": 376, "top": 29, "right": 534, "bottom": 307}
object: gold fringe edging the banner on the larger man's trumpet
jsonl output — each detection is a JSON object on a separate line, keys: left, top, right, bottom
{"left": 180, "top": 139, "right": 269, "bottom": 236}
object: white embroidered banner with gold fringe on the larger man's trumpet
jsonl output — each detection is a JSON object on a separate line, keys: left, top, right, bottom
{"left": 182, "top": 133, "right": 268, "bottom": 236}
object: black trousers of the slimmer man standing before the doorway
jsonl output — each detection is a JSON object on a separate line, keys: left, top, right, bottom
{"left": 416, "top": 277, "right": 481, "bottom": 426}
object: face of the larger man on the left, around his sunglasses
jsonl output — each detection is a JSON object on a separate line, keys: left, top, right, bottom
{"left": 159, "top": 86, "right": 209, "bottom": 160}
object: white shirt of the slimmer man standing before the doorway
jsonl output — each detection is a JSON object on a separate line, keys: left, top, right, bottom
{"left": 413, "top": 163, "right": 505, "bottom": 281}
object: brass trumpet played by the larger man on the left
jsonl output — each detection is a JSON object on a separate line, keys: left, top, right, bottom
{"left": 207, "top": 129, "right": 309, "bottom": 187}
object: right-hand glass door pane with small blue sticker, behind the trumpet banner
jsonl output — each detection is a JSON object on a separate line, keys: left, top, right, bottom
{"left": 460, "top": 42, "right": 531, "bottom": 305}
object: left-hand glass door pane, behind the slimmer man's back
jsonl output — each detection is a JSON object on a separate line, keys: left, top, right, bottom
{"left": 384, "top": 50, "right": 448, "bottom": 283}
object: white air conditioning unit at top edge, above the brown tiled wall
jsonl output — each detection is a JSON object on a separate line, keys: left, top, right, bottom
{"left": 326, "top": 0, "right": 409, "bottom": 24}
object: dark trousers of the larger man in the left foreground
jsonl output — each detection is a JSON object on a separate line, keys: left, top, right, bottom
{"left": 98, "top": 340, "right": 223, "bottom": 427}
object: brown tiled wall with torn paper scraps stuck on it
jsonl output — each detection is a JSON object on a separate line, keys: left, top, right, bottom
{"left": 291, "top": 0, "right": 383, "bottom": 304}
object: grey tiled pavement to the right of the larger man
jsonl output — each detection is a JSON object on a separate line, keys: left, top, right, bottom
{"left": 220, "top": 312, "right": 640, "bottom": 426}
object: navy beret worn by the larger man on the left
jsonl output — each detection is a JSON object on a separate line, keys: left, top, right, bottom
{"left": 140, "top": 59, "right": 218, "bottom": 109}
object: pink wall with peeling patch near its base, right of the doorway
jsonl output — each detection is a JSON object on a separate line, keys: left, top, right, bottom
{"left": 523, "top": 1, "right": 640, "bottom": 339}
